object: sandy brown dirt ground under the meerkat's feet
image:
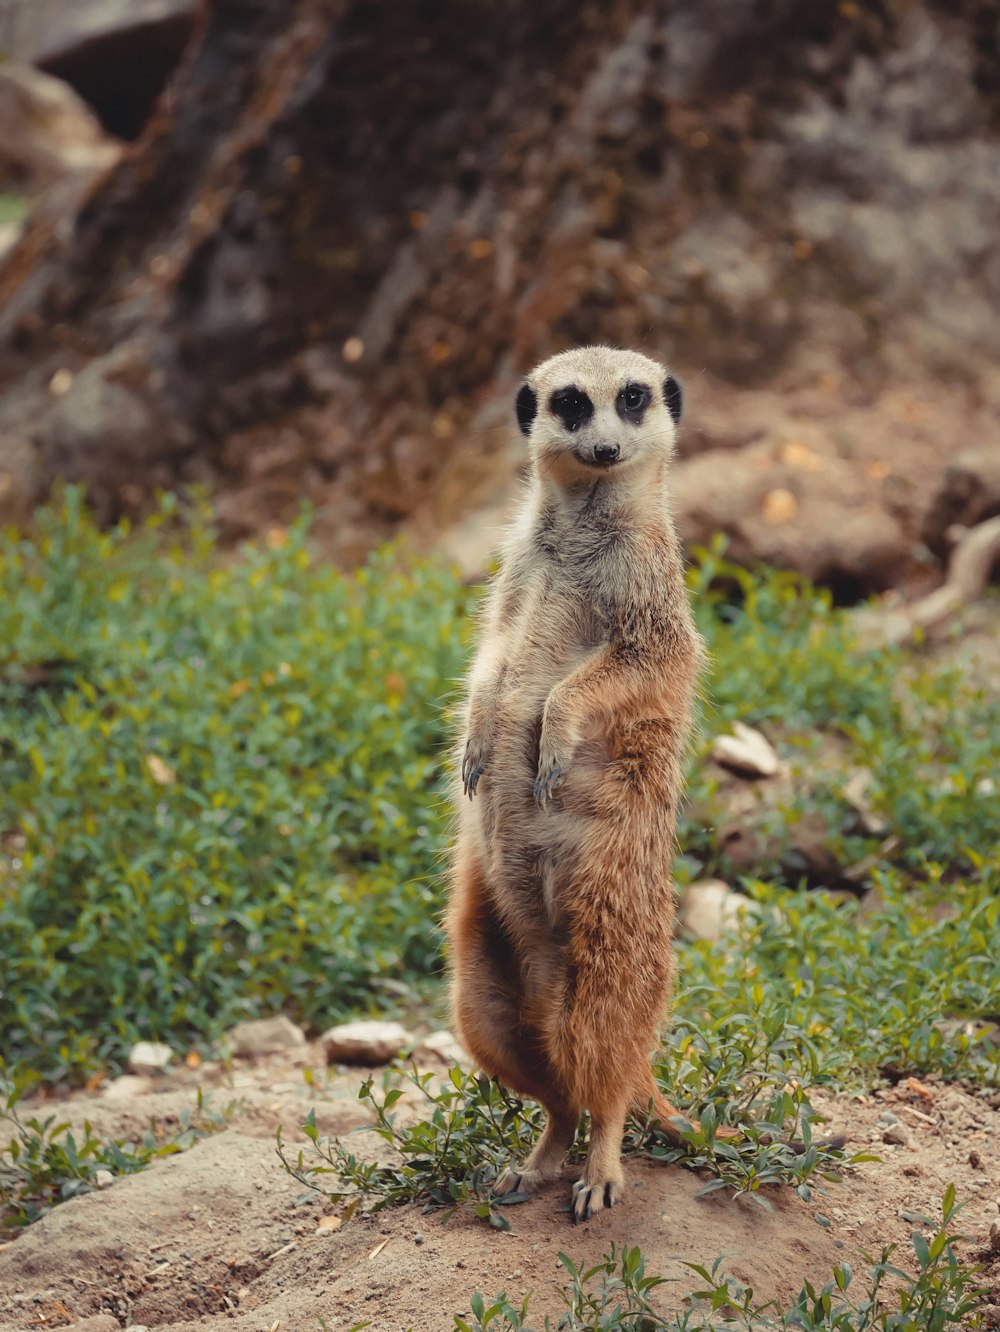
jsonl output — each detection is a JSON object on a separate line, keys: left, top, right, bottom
{"left": 0, "top": 1046, "right": 1000, "bottom": 1332}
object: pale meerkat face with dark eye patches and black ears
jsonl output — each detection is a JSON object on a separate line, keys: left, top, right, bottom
{"left": 515, "top": 346, "right": 682, "bottom": 481}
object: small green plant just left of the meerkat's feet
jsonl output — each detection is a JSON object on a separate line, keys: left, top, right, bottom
{"left": 277, "top": 1068, "right": 542, "bottom": 1229}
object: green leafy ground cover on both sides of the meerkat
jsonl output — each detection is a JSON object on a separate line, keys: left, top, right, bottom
{"left": 0, "top": 489, "right": 1000, "bottom": 1081}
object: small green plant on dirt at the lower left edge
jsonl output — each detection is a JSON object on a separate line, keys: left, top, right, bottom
{"left": 0, "top": 1059, "right": 225, "bottom": 1233}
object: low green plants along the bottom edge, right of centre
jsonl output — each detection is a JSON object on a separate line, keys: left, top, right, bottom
{"left": 454, "top": 1185, "right": 985, "bottom": 1332}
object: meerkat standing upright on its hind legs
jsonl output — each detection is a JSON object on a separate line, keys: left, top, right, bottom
{"left": 446, "top": 346, "right": 719, "bottom": 1221}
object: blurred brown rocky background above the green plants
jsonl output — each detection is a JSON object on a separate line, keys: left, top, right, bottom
{"left": 0, "top": 0, "right": 1000, "bottom": 601}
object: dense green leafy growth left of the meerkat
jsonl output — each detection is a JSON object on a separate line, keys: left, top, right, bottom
{"left": 0, "top": 490, "right": 466, "bottom": 1076}
